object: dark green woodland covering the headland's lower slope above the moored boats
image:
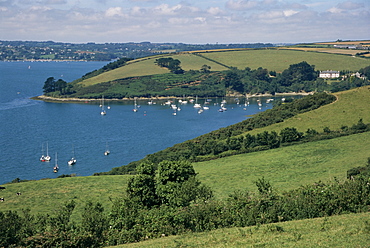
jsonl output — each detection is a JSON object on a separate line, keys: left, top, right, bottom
{"left": 43, "top": 58, "right": 370, "bottom": 99}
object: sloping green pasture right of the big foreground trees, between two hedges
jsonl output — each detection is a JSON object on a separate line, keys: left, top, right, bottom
{"left": 193, "top": 132, "right": 370, "bottom": 198}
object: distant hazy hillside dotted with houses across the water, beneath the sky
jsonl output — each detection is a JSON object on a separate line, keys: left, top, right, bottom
{"left": 0, "top": 40, "right": 274, "bottom": 61}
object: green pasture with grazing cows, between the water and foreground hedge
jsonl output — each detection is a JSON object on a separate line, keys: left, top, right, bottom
{"left": 0, "top": 175, "right": 130, "bottom": 220}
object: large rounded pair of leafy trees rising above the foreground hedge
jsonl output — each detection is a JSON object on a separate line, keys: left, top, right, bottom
{"left": 127, "top": 160, "right": 213, "bottom": 208}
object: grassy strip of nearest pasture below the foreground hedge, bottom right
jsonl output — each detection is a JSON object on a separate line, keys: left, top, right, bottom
{"left": 114, "top": 213, "right": 370, "bottom": 248}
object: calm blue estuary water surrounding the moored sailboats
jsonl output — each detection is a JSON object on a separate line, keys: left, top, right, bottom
{"left": 0, "top": 62, "right": 284, "bottom": 184}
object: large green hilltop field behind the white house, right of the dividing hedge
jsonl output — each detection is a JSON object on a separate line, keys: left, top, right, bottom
{"left": 202, "top": 49, "right": 370, "bottom": 72}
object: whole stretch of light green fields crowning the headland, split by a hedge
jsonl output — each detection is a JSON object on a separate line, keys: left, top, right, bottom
{"left": 76, "top": 49, "right": 370, "bottom": 85}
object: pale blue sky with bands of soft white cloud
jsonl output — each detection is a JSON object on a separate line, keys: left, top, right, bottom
{"left": 0, "top": 0, "right": 370, "bottom": 44}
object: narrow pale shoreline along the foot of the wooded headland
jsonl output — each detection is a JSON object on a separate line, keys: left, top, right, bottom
{"left": 31, "top": 92, "right": 315, "bottom": 103}
